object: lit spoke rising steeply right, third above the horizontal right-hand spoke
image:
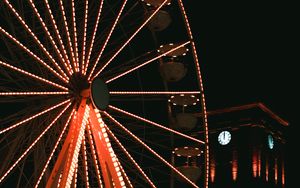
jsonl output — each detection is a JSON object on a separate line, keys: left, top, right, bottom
{"left": 88, "top": 0, "right": 127, "bottom": 80}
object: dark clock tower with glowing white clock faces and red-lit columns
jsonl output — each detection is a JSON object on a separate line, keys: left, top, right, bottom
{"left": 199, "top": 103, "right": 288, "bottom": 188}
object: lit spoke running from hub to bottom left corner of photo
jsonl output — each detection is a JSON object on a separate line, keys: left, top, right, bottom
{"left": 0, "top": 102, "right": 72, "bottom": 183}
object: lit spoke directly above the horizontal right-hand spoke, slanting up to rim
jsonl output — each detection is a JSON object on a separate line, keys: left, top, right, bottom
{"left": 106, "top": 41, "right": 190, "bottom": 83}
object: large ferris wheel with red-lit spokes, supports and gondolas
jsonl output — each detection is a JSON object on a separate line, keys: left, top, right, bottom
{"left": 0, "top": 0, "right": 209, "bottom": 188}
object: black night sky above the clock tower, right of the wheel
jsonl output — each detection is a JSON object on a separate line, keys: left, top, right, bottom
{"left": 185, "top": 0, "right": 300, "bottom": 186}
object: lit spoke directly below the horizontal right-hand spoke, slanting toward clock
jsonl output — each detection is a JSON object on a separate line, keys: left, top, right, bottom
{"left": 108, "top": 105, "right": 204, "bottom": 144}
